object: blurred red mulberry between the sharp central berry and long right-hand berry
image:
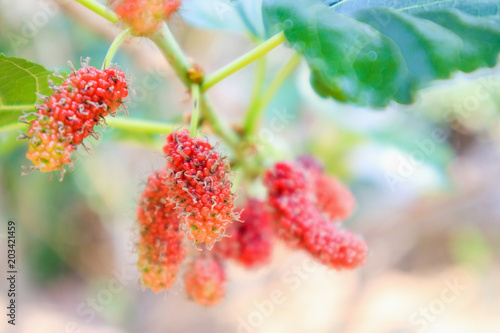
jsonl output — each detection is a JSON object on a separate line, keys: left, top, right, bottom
{"left": 214, "top": 199, "right": 274, "bottom": 268}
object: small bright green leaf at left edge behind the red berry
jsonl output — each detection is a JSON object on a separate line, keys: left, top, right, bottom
{"left": 0, "top": 54, "right": 62, "bottom": 129}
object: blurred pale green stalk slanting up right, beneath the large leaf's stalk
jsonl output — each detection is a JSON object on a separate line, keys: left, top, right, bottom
{"left": 243, "top": 53, "right": 300, "bottom": 136}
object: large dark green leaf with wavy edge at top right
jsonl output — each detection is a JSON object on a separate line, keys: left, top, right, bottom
{"left": 263, "top": 0, "right": 500, "bottom": 107}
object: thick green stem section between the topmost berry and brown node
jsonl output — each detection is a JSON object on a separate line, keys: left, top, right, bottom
{"left": 151, "top": 24, "right": 193, "bottom": 87}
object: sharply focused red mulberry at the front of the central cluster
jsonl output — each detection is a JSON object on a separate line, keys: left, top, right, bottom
{"left": 163, "top": 130, "right": 237, "bottom": 248}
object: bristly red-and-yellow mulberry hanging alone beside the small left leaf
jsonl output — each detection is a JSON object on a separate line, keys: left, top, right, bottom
{"left": 24, "top": 65, "right": 128, "bottom": 174}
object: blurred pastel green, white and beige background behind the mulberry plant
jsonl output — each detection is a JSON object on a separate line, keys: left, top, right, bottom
{"left": 0, "top": 0, "right": 500, "bottom": 333}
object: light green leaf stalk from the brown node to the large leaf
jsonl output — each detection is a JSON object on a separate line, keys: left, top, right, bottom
{"left": 201, "top": 31, "right": 286, "bottom": 91}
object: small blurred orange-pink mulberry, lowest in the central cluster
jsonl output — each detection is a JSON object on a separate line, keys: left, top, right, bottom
{"left": 184, "top": 255, "right": 226, "bottom": 306}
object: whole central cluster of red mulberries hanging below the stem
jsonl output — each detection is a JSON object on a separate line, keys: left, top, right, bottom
{"left": 137, "top": 145, "right": 367, "bottom": 306}
